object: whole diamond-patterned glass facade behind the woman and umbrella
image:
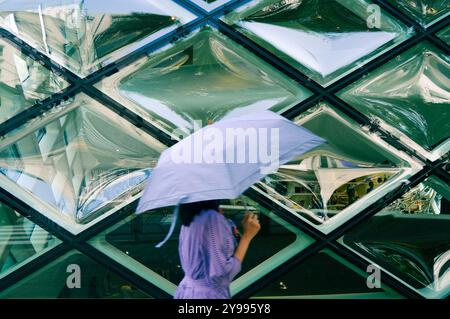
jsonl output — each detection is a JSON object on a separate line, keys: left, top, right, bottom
{"left": 0, "top": 0, "right": 450, "bottom": 299}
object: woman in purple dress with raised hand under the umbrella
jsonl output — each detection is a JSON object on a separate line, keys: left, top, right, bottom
{"left": 175, "top": 201, "right": 260, "bottom": 299}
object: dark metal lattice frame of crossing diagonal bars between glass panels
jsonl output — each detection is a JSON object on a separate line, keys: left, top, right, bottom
{"left": 0, "top": 0, "right": 450, "bottom": 298}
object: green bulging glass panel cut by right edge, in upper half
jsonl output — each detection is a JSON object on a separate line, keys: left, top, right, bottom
{"left": 340, "top": 44, "right": 450, "bottom": 160}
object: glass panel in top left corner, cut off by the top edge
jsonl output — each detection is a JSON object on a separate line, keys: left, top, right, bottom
{"left": 0, "top": 0, "right": 194, "bottom": 76}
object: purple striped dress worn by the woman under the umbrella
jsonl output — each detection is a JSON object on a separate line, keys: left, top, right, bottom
{"left": 175, "top": 210, "right": 241, "bottom": 299}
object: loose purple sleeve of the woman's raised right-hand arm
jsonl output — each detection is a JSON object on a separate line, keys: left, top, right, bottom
{"left": 205, "top": 213, "right": 241, "bottom": 282}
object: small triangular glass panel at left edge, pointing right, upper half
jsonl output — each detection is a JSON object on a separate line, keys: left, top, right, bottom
{"left": 0, "top": 38, "right": 67, "bottom": 124}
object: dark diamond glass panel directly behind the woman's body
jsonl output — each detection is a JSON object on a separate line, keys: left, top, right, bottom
{"left": 91, "top": 196, "right": 313, "bottom": 294}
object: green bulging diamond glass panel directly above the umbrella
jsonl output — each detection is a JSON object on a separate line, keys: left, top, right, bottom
{"left": 99, "top": 28, "right": 310, "bottom": 133}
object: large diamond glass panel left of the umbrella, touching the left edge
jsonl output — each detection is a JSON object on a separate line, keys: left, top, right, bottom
{"left": 0, "top": 94, "right": 165, "bottom": 233}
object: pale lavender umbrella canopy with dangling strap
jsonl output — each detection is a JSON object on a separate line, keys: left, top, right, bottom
{"left": 136, "top": 111, "right": 325, "bottom": 248}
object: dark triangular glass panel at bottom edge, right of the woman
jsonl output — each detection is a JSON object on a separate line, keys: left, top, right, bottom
{"left": 253, "top": 249, "right": 400, "bottom": 299}
